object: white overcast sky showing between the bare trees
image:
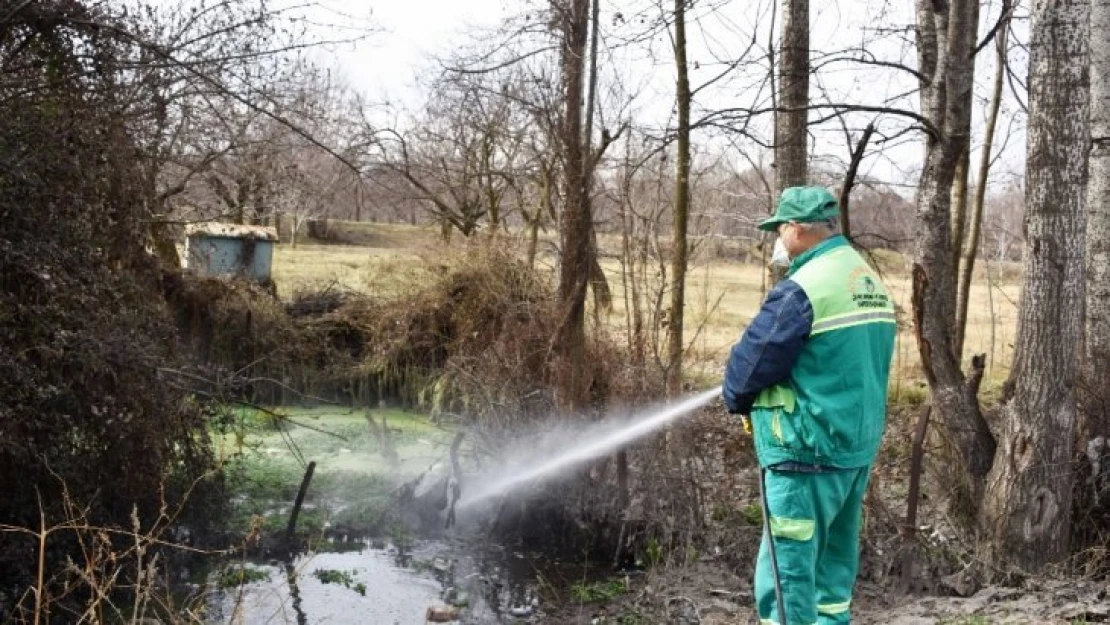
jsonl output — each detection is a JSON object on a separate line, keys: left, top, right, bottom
{"left": 255, "top": 0, "right": 1025, "bottom": 195}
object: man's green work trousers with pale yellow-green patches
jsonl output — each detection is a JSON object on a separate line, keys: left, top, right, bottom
{"left": 755, "top": 466, "right": 871, "bottom": 625}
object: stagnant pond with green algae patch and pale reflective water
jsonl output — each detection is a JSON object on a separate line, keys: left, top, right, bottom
{"left": 208, "top": 406, "right": 568, "bottom": 625}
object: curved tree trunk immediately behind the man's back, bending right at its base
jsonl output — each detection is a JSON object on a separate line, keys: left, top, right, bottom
{"left": 912, "top": 0, "right": 995, "bottom": 510}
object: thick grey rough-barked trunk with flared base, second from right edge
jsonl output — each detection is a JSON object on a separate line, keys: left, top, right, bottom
{"left": 980, "top": 0, "right": 1087, "bottom": 572}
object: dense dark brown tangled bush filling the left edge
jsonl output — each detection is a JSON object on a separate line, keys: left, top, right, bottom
{"left": 0, "top": 2, "right": 225, "bottom": 622}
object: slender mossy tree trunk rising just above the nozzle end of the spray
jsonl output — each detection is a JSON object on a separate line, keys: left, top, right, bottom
{"left": 667, "top": 0, "right": 692, "bottom": 396}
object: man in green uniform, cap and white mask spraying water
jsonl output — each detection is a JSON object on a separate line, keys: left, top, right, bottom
{"left": 724, "top": 187, "right": 896, "bottom": 625}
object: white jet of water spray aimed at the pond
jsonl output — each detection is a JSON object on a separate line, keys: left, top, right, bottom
{"left": 458, "top": 386, "right": 720, "bottom": 508}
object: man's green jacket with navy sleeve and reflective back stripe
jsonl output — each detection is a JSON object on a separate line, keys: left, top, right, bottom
{"left": 724, "top": 236, "right": 897, "bottom": 468}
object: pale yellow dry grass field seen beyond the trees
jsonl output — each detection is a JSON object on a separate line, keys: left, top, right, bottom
{"left": 273, "top": 224, "right": 1019, "bottom": 401}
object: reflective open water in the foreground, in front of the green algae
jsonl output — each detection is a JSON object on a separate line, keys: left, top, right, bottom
{"left": 208, "top": 543, "right": 552, "bottom": 625}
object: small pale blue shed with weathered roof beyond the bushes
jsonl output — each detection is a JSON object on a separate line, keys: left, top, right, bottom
{"left": 183, "top": 222, "right": 278, "bottom": 282}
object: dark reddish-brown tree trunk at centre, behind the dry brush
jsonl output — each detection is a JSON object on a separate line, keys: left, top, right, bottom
{"left": 553, "top": 0, "right": 591, "bottom": 412}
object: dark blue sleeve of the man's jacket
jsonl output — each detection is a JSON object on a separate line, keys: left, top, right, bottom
{"left": 724, "top": 280, "right": 814, "bottom": 414}
